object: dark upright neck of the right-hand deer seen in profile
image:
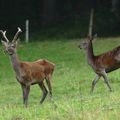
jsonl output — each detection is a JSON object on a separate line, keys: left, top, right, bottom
{"left": 87, "top": 41, "right": 94, "bottom": 65}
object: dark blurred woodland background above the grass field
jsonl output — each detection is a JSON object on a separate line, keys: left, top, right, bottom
{"left": 0, "top": 0, "right": 120, "bottom": 39}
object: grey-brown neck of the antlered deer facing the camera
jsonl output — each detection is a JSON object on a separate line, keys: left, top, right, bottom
{"left": 10, "top": 53, "right": 21, "bottom": 77}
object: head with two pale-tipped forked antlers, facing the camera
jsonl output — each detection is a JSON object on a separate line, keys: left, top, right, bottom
{"left": 0, "top": 27, "right": 22, "bottom": 55}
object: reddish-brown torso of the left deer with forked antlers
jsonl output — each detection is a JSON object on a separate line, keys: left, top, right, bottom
{"left": 20, "top": 59, "right": 55, "bottom": 80}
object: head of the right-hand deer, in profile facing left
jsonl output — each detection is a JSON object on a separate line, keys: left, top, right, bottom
{"left": 78, "top": 34, "right": 97, "bottom": 50}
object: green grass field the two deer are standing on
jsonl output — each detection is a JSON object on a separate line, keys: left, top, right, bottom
{"left": 0, "top": 37, "right": 120, "bottom": 120}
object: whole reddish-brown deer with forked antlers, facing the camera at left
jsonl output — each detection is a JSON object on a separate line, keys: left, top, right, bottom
{"left": 0, "top": 27, "right": 55, "bottom": 107}
